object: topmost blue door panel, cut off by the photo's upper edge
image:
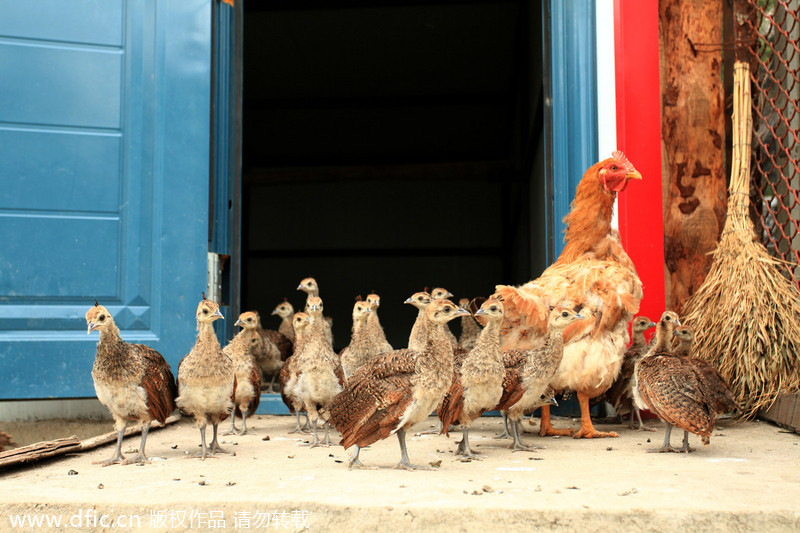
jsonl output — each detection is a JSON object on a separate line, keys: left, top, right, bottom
{"left": 0, "top": 0, "right": 125, "bottom": 46}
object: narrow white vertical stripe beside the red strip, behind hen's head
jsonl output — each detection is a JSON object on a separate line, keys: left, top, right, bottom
{"left": 595, "top": 0, "right": 619, "bottom": 229}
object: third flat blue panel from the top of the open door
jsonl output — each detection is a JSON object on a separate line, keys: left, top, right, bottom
{"left": 0, "top": 127, "right": 122, "bottom": 213}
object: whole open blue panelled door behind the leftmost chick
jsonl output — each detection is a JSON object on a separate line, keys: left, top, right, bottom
{"left": 0, "top": 0, "right": 212, "bottom": 399}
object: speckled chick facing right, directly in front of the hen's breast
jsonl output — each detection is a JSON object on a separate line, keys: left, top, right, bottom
{"left": 497, "top": 309, "right": 584, "bottom": 450}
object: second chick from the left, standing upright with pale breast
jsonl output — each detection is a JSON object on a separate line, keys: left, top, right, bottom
{"left": 175, "top": 298, "right": 236, "bottom": 459}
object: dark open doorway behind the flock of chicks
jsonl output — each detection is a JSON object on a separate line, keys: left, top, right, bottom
{"left": 242, "top": 1, "right": 544, "bottom": 350}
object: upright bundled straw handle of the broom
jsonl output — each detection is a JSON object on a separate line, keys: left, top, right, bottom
{"left": 723, "top": 61, "right": 755, "bottom": 240}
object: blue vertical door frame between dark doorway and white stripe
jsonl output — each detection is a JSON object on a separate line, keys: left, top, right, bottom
{"left": 545, "top": 0, "right": 596, "bottom": 264}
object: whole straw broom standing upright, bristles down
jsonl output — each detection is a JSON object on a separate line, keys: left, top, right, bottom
{"left": 683, "top": 61, "right": 800, "bottom": 418}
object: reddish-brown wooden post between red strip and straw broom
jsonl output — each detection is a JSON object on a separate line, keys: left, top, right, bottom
{"left": 659, "top": 0, "right": 733, "bottom": 312}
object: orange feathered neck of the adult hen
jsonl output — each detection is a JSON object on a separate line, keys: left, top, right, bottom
{"left": 556, "top": 161, "right": 617, "bottom": 263}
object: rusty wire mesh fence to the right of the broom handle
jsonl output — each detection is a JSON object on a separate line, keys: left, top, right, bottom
{"left": 742, "top": 0, "right": 800, "bottom": 286}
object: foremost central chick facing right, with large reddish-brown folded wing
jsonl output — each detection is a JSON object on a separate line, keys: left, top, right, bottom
{"left": 328, "top": 300, "right": 468, "bottom": 469}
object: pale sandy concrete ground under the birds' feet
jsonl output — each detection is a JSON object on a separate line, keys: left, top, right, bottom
{"left": 0, "top": 416, "right": 800, "bottom": 532}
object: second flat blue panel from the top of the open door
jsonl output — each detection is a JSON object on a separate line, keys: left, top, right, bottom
{"left": 0, "top": 42, "right": 122, "bottom": 128}
